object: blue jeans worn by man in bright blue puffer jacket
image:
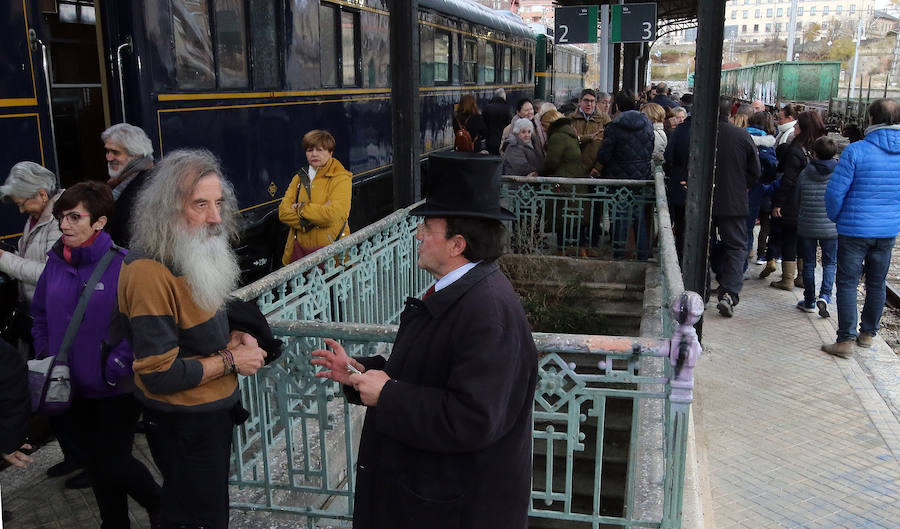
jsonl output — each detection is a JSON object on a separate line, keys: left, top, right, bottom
{"left": 837, "top": 235, "right": 896, "bottom": 342}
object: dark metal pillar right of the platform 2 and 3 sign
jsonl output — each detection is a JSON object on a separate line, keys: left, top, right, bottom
{"left": 682, "top": 0, "right": 725, "bottom": 335}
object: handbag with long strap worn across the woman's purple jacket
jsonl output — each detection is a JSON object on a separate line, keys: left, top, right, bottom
{"left": 28, "top": 245, "right": 121, "bottom": 415}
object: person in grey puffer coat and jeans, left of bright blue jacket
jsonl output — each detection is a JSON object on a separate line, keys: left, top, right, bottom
{"left": 797, "top": 136, "right": 837, "bottom": 318}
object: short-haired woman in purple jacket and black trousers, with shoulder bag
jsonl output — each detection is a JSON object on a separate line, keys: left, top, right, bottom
{"left": 31, "top": 182, "right": 160, "bottom": 527}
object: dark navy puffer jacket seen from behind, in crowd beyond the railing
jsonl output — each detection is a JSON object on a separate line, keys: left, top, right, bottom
{"left": 597, "top": 110, "right": 653, "bottom": 180}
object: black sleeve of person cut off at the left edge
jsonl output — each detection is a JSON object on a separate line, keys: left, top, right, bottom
{"left": 0, "top": 339, "right": 31, "bottom": 454}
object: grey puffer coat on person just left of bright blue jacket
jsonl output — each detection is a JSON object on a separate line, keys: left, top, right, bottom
{"left": 797, "top": 159, "right": 837, "bottom": 239}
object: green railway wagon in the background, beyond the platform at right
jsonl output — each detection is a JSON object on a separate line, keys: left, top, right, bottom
{"left": 721, "top": 61, "right": 841, "bottom": 106}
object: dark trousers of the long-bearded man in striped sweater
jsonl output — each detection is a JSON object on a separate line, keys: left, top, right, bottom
{"left": 144, "top": 409, "right": 234, "bottom": 529}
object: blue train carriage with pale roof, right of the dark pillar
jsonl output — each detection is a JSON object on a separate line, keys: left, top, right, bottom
{"left": 419, "top": 0, "right": 535, "bottom": 156}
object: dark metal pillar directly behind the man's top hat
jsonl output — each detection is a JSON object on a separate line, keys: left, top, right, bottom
{"left": 389, "top": 0, "right": 422, "bottom": 208}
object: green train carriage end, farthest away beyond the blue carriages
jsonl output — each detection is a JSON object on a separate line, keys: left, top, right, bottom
{"left": 534, "top": 32, "right": 588, "bottom": 106}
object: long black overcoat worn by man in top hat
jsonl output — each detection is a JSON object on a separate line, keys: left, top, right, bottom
{"left": 344, "top": 263, "right": 537, "bottom": 529}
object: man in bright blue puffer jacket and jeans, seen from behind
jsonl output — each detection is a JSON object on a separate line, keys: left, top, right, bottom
{"left": 822, "top": 99, "right": 900, "bottom": 358}
